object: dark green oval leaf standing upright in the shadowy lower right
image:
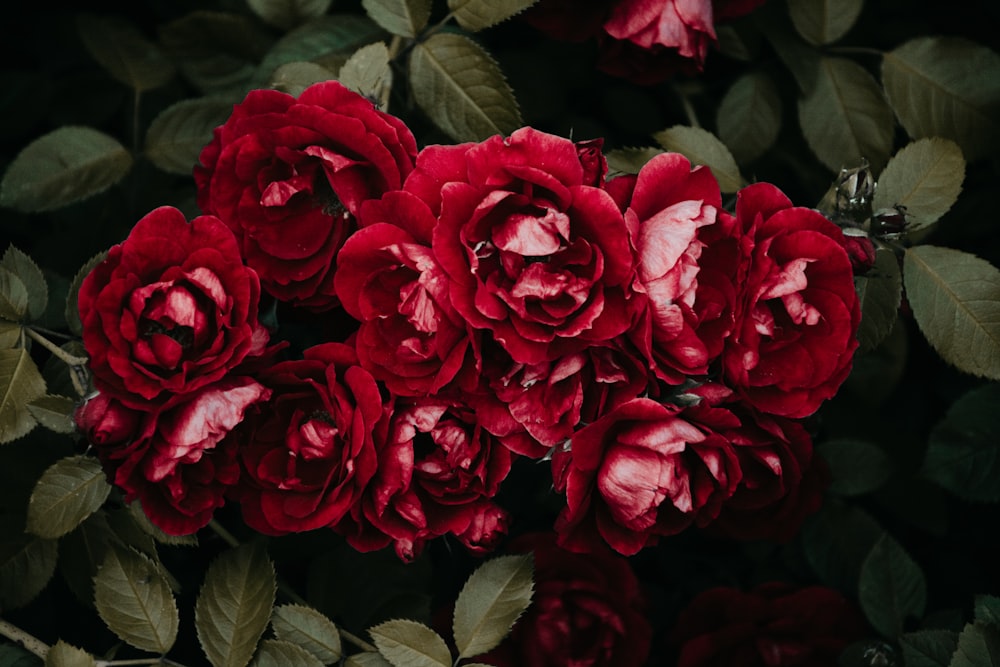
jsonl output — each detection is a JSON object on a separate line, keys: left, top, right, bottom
{"left": 858, "top": 533, "right": 927, "bottom": 639}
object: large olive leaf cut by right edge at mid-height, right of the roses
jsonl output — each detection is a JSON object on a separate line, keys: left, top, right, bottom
{"left": 903, "top": 245, "right": 1000, "bottom": 380}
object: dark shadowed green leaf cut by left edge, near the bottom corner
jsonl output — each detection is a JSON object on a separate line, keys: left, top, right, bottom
{"left": 0, "top": 535, "right": 59, "bottom": 611}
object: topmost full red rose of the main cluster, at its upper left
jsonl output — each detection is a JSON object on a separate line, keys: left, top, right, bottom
{"left": 194, "top": 81, "right": 416, "bottom": 310}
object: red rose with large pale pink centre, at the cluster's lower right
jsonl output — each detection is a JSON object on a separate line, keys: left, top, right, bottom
{"left": 552, "top": 398, "right": 741, "bottom": 556}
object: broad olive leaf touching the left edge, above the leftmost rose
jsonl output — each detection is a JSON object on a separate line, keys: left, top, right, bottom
{"left": 0, "top": 126, "right": 132, "bottom": 213}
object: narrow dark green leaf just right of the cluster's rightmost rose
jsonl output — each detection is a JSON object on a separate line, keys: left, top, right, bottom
{"left": 854, "top": 248, "right": 903, "bottom": 352}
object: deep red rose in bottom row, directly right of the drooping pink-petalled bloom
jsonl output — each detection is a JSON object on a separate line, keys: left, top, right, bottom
{"left": 232, "top": 343, "right": 385, "bottom": 535}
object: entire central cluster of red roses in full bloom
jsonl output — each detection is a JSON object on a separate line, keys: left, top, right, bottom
{"left": 77, "top": 82, "right": 860, "bottom": 560}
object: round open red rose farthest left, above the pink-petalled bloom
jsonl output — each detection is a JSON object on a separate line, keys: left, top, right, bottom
{"left": 79, "top": 206, "right": 267, "bottom": 410}
